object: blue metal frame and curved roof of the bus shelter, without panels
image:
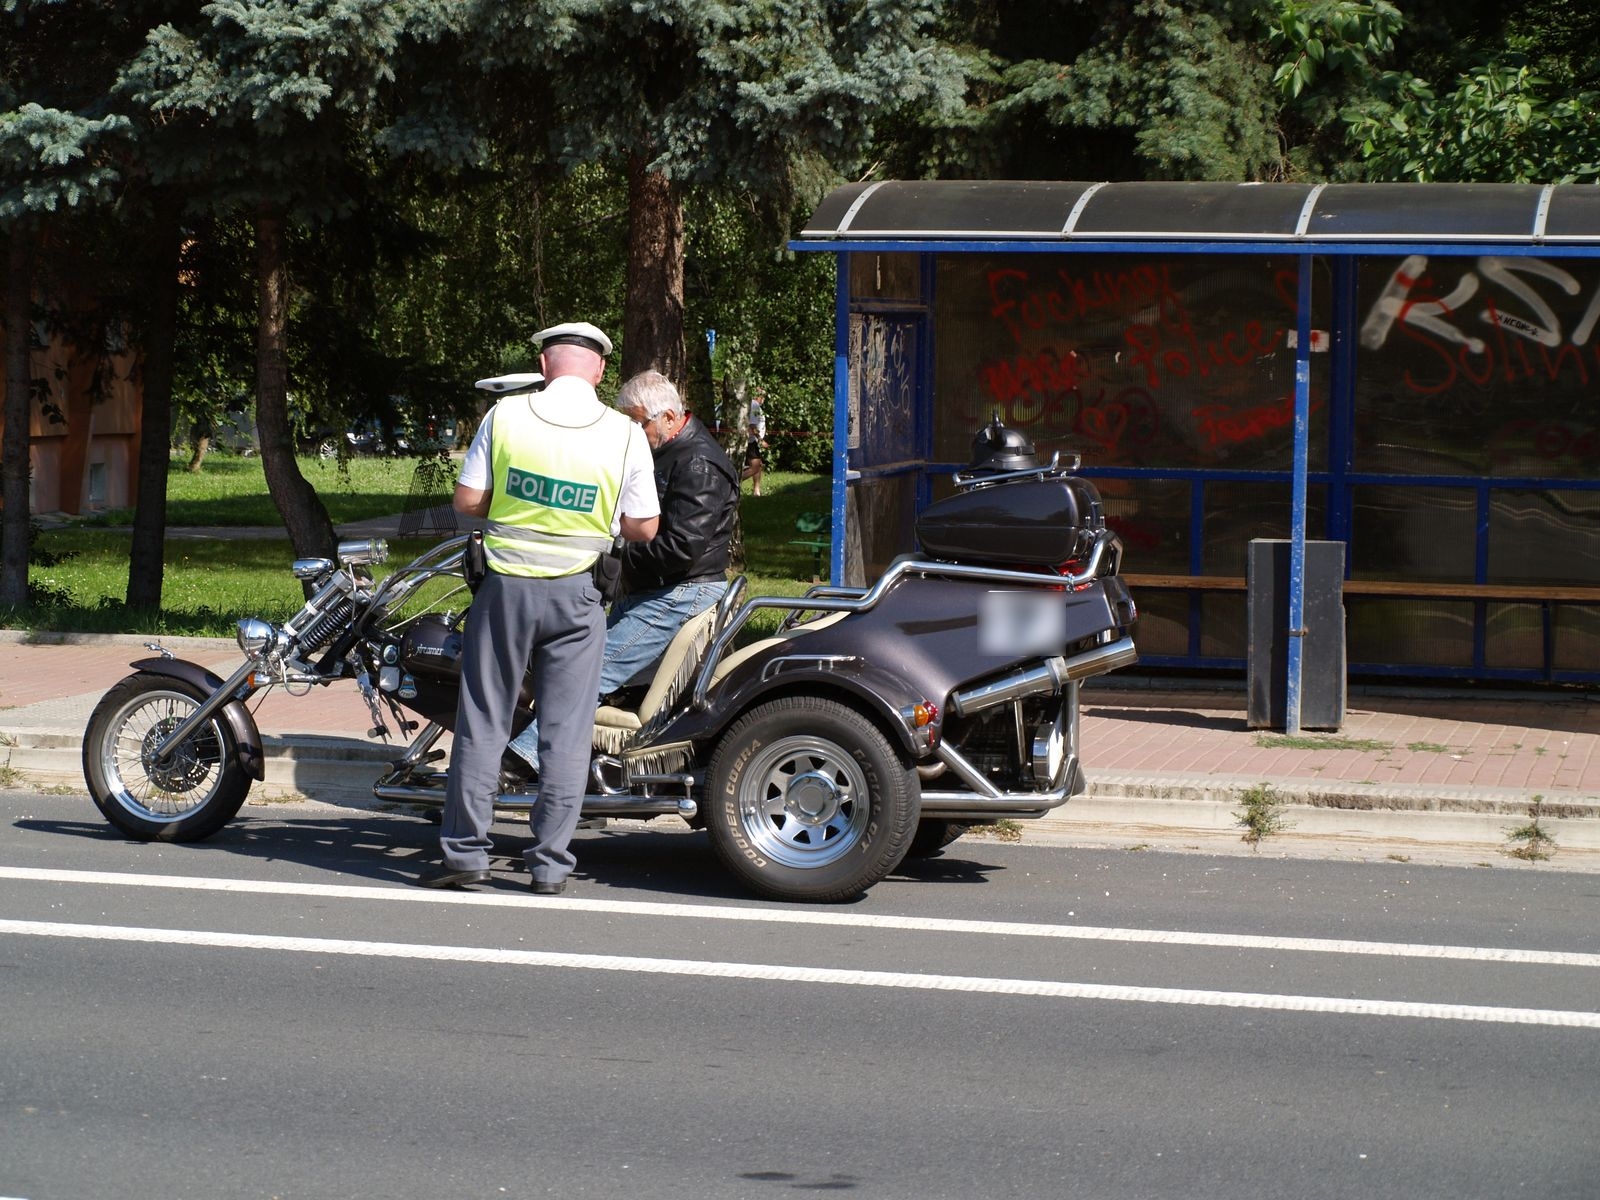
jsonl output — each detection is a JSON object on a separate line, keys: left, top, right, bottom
{"left": 792, "top": 181, "right": 1600, "bottom": 730}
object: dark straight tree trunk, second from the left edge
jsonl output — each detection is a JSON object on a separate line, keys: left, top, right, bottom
{"left": 128, "top": 208, "right": 181, "bottom": 610}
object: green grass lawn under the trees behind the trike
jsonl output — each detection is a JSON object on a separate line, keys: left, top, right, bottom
{"left": 0, "top": 456, "right": 829, "bottom": 637}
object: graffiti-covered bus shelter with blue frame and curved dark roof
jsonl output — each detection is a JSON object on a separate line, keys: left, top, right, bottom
{"left": 792, "top": 181, "right": 1600, "bottom": 720}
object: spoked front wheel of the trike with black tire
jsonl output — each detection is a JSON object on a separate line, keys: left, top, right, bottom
{"left": 83, "top": 674, "right": 250, "bottom": 842}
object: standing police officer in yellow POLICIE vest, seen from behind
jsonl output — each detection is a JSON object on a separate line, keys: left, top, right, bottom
{"left": 418, "top": 322, "right": 661, "bottom": 896}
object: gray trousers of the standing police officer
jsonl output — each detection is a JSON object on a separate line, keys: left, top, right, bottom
{"left": 438, "top": 571, "right": 605, "bottom": 883}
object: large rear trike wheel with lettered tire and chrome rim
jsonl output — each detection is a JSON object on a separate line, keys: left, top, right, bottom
{"left": 706, "top": 696, "right": 922, "bottom": 904}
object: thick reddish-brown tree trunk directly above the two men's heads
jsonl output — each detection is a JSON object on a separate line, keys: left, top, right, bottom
{"left": 622, "top": 155, "right": 688, "bottom": 386}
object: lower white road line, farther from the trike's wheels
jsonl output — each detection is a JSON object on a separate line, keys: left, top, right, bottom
{"left": 0, "top": 920, "right": 1600, "bottom": 1029}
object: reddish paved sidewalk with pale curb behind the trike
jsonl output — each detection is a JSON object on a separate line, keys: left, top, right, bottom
{"left": 0, "top": 630, "right": 1600, "bottom": 870}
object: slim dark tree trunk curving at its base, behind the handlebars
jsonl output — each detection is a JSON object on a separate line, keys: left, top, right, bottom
{"left": 256, "top": 208, "right": 336, "bottom": 558}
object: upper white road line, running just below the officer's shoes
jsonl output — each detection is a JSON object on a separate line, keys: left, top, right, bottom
{"left": 0, "top": 867, "right": 1600, "bottom": 968}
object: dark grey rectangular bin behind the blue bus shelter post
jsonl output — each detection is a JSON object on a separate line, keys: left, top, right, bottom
{"left": 1245, "top": 538, "right": 1347, "bottom": 730}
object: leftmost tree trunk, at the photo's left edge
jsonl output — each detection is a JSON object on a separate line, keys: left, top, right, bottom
{"left": 0, "top": 218, "right": 34, "bottom": 608}
